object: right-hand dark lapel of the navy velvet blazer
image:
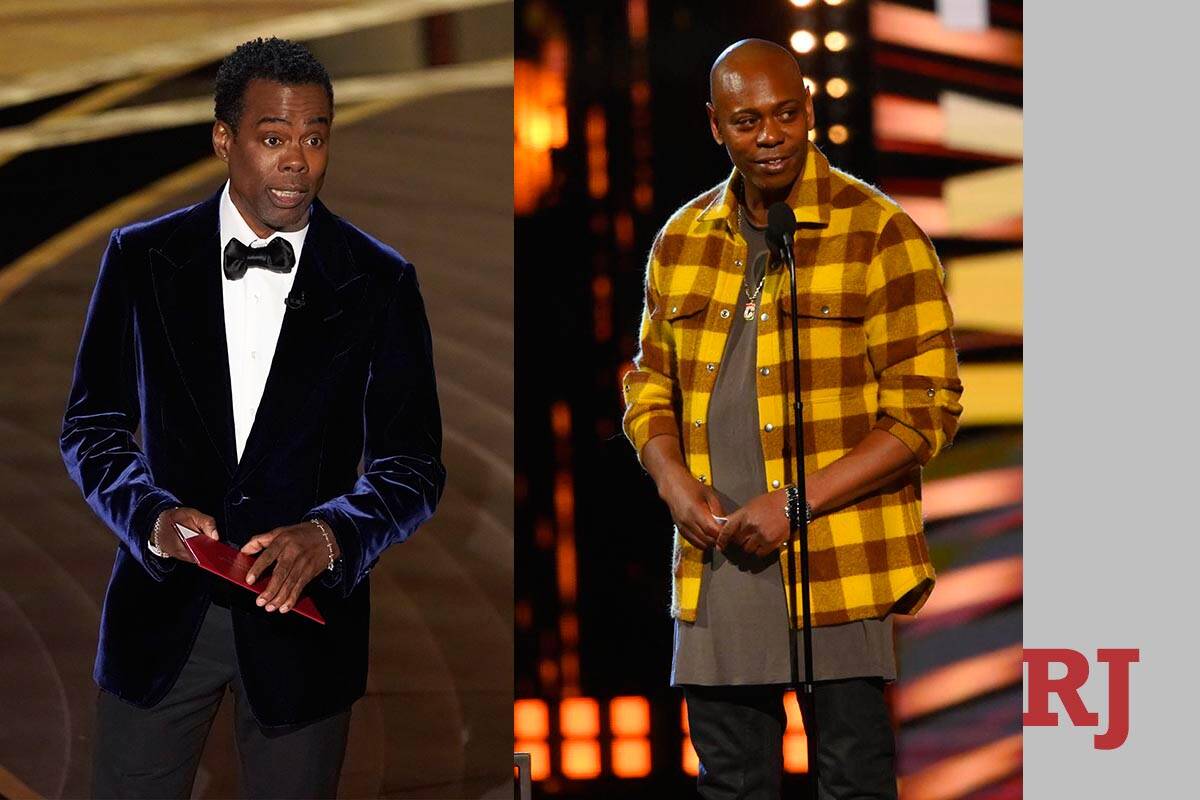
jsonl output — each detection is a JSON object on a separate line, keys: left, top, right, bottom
{"left": 235, "top": 200, "right": 367, "bottom": 480}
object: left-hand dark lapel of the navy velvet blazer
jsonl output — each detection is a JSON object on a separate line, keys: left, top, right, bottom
{"left": 150, "top": 192, "right": 236, "bottom": 475}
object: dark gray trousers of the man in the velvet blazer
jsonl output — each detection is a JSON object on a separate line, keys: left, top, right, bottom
{"left": 92, "top": 604, "right": 350, "bottom": 800}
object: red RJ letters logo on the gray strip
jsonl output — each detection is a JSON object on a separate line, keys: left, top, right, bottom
{"left": 1022, "top": 648, "right": 1139, "bottom": 750}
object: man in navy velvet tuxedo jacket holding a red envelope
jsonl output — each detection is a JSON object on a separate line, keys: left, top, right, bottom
{"left": 61, "top": 40, "right": 445, "bottom": 796}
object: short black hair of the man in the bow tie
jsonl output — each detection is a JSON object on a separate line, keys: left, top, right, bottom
{"left": 212, "top": 36, "right": 334, "bottom": 134}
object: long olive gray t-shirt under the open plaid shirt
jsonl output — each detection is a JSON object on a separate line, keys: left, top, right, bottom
{"left": 671, "top": 214, "right": 896, "bottom": 686}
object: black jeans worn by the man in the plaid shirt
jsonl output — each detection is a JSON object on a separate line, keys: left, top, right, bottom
{"left": 683, "top": 678, "right": 896, "bottom": 800}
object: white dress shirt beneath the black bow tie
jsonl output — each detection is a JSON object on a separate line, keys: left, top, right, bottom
{"left": 217, "top": 181, "right": 308, "bottom": 461}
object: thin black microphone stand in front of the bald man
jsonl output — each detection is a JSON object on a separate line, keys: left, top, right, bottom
{"left": 779, "top": 225, "right": 817, "bottom": 800}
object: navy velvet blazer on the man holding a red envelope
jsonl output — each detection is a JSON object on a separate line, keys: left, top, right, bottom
{"left": 61, "top": 193, "right": 445, "bottom": 726}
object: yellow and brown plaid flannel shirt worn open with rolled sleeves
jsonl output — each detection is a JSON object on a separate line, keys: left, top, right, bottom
{"left": 624, "top": 145, "right": 962, "bottom": 626}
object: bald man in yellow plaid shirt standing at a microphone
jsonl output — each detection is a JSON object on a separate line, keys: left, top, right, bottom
{"left": 624, "top": 40, "right": 962, "bottom": 799}
